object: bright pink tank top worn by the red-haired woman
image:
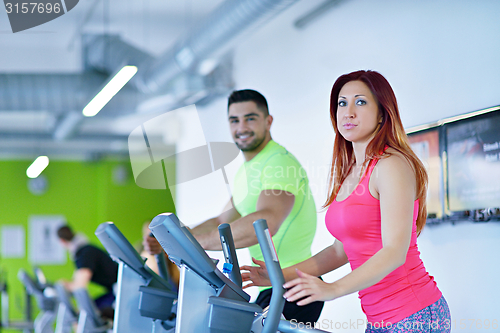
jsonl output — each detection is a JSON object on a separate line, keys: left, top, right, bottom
{"left": 325, "top": 160, "right": 441, "bottom": 325}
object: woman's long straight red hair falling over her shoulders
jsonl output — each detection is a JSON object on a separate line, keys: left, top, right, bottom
{"left": 323, "top": 71, "right": 427, "bottom": 235}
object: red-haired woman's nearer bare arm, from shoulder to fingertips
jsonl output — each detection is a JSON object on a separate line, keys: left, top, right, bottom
{"left": 285, "top": 154, "right": 416, "bottom": 305}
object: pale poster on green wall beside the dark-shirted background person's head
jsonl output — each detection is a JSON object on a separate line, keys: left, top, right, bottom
{"left": 28, "top": 215, "right": 67, "bottom": 265}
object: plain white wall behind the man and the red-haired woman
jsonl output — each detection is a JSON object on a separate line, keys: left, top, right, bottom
{"left": 177, "top": 0, "right": 500, "bottom": 332}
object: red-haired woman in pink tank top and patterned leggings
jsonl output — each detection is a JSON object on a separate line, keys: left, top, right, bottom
{"left": 242, "top": 71, "right": 451, "bottom": 333}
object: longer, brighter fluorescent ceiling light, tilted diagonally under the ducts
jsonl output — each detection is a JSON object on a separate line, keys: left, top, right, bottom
{"left": 83, "top": 66, "right": 137, "bottom": 117}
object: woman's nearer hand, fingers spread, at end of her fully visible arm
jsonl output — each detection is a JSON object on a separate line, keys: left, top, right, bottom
{"left": 283, "top": 269, "right": 338, "bottom": 305}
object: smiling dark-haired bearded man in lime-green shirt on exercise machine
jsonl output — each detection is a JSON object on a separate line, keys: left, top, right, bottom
{"left": 143, "top": 90, "right": 324, "bottom": 323}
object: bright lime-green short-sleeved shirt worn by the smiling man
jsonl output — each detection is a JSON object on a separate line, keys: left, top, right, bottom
{"left": 233, "top": 140, "right": 316, "bottom": 268}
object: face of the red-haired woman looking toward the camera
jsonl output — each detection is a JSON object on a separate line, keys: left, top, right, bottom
{"left": 337, "top": 81, "right": 382, "bottom": 143}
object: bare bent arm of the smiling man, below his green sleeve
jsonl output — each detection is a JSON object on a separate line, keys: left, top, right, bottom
{"left": 193, "top": 190, "right": 295, "bottom": 250}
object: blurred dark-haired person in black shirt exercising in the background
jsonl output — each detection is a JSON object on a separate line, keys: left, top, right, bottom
{"left": 57, "top": 225, "right": 118, "bottom": 318}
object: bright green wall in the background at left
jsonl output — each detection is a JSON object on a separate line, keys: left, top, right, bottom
{"left": 0, "top": 160, "right": 174, "bottom": 319}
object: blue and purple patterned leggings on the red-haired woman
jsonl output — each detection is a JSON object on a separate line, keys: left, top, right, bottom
{"left": 365, "top": 296, "right": 451, "bottom": 333}
